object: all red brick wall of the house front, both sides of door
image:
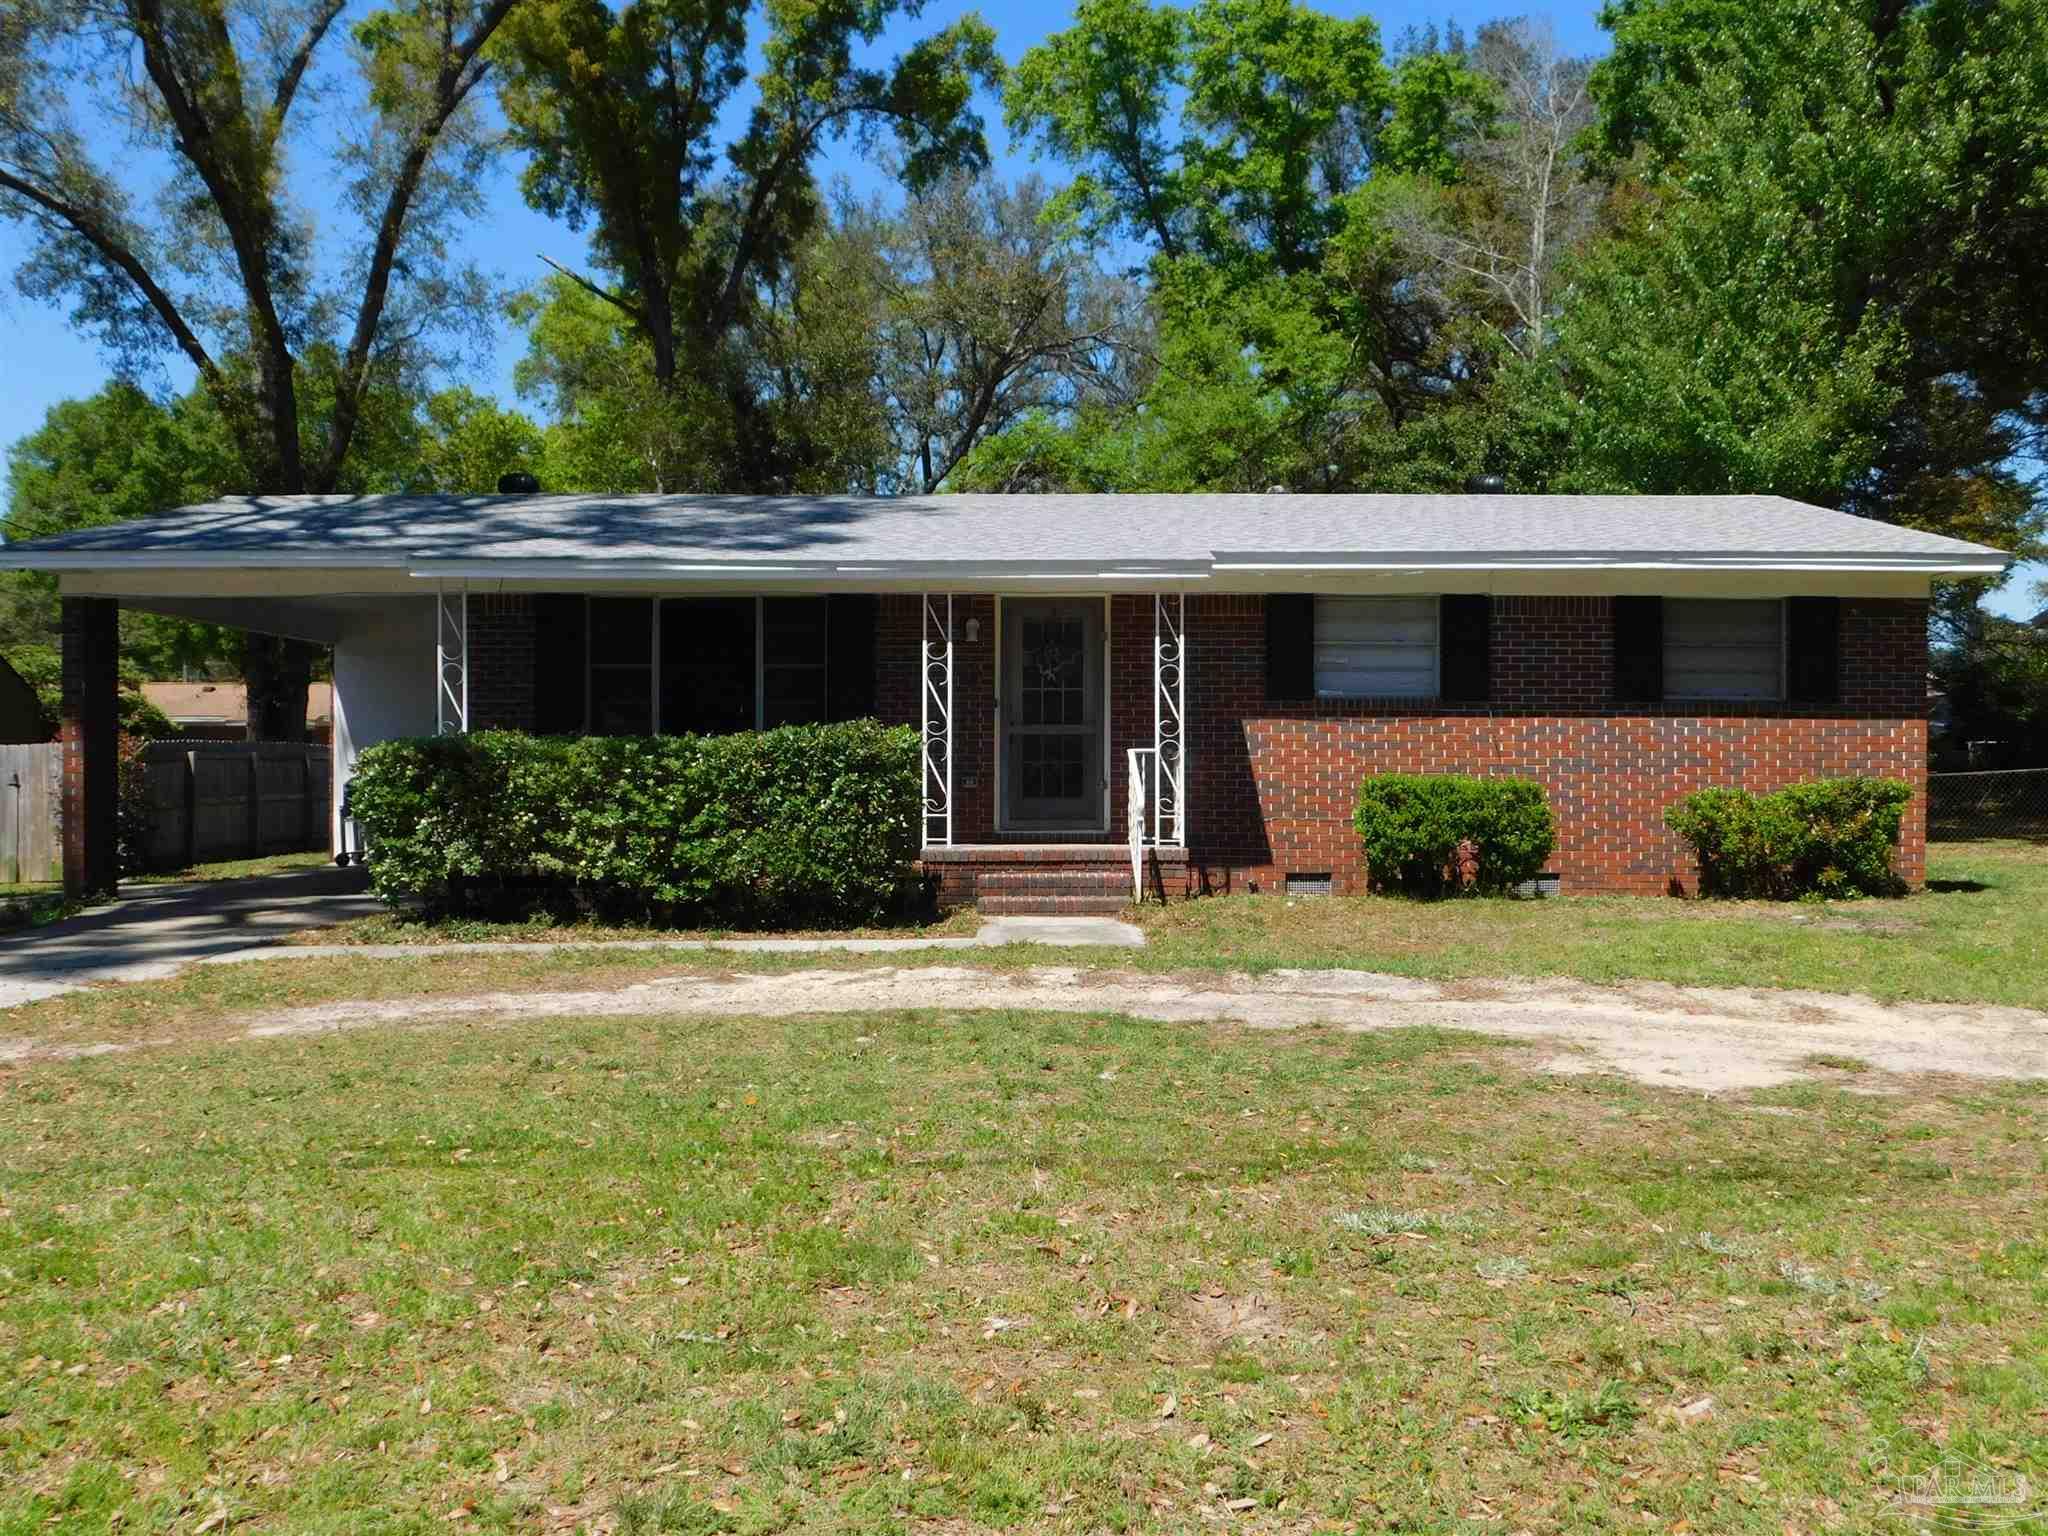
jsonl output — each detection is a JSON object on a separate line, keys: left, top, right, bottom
{"left": 469, "top": 594, "right": 1927, "bottom": 891}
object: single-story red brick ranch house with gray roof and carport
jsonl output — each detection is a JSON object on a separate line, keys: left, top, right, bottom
{"left": 8, "top": 494, "right": 2005, "bottom": 911}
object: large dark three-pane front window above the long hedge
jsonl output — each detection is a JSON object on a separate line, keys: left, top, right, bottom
{"left": 588, "top": 598, "right": 831, "bottom": 735}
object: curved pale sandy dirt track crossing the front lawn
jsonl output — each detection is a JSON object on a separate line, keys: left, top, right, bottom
{"left": 0, "top": 967, "right": 2048, "bottom": 1092}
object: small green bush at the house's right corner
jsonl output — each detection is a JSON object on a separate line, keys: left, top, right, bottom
{"left": 1665, "top": 778, "right": 1913, "bottom": 899}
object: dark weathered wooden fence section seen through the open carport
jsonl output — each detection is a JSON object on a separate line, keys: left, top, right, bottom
{"left": 142, "top": 741, "right": 334, "bottom": 870}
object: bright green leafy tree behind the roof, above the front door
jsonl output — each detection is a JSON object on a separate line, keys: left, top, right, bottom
{"left": 983, "top": 0, "right": 1491, "bottom": 489}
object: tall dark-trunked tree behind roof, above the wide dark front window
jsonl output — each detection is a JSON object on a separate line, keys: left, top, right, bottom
{"left": 502, "top": 0, "right": 999, "bottom": 489}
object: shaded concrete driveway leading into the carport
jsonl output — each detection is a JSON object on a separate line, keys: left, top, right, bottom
{"left": 0, "top": 868, "right": 383, "bottom": 1008}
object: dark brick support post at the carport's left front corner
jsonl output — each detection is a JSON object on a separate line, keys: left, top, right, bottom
{"left": 57, "top": 598, "right": 121, "bottom": 901}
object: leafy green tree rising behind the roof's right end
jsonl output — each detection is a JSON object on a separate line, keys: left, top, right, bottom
{"left": 1589, "top": 0, "right": 2048, "bottom": 573}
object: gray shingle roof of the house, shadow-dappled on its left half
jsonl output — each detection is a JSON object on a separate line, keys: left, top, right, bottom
{"left": 0, "top": 494, "right": 1999, "bottom": 567}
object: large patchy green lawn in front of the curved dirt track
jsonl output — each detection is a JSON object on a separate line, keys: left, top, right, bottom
{"left": 0, "top": 1015, "right": 2048, "bottom": 1536}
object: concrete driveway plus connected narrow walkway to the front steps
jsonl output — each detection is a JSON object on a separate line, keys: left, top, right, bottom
{"left": 0, "top": 868, "right": 1145, "bottom": 1008}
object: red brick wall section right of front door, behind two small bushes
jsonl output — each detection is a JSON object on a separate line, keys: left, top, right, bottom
{"left": 1190, "top": 598, "right": 1927, "bottom": 893}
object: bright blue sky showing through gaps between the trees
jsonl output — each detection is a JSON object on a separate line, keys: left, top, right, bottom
{"left": 0, "top": 0, "right": 2048, "bottom": 612}
